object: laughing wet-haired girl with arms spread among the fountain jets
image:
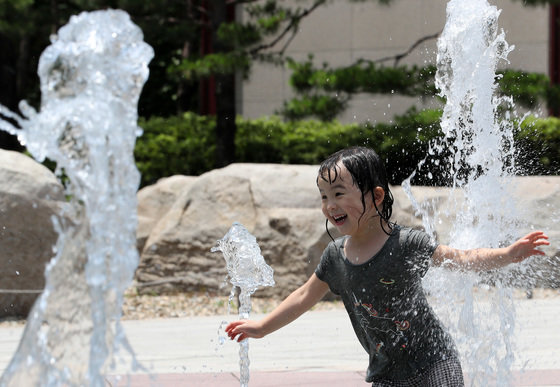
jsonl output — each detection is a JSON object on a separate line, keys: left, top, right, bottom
{"left": 226, "top": 147, "right": 549, "bottom": 387}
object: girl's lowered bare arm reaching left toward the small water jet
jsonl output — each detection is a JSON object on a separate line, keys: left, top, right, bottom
{"left": 226, "top": 274, "right": 329, "bottom": 341}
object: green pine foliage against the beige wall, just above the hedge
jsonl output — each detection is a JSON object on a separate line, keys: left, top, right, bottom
{"left": 278, "top": 56, "right": 560, "bottom": 121}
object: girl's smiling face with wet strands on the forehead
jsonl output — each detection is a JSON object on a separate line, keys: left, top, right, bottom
{"left": 317, "top": 163, "right": 375, "bottom": 235}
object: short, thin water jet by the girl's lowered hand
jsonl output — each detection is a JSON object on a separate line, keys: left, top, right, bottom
{"left": 212, "top": 222, "right": 274, "bottom": 387}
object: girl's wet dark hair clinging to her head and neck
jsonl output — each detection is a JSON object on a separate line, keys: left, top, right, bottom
{"left": 317, "top": 146, "right": 394, "bottom": 239}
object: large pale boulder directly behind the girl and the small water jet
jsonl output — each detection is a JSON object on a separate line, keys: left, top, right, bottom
{"left": 137, "top": 164, "right": 328, "bottom": 295}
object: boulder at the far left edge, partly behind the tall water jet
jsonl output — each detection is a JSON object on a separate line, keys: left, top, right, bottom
{"left": 0, "top": 150, "right": 64, "bottom": 317}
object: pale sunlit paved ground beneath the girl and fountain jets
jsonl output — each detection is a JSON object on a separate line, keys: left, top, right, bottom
{"left": 0, "top": 297, "right": 560, "bottom": 387}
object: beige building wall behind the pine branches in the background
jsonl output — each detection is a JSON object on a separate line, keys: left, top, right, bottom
{"left": 238, "top": 0, "right": 549, "bottom": 123}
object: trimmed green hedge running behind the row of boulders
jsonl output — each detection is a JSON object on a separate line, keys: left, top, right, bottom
{"left": 135, "top": 108, "right": 560, "bottom": 186}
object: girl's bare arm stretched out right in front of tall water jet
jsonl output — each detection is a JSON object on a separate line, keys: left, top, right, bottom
{"left": 432, "top": 231, "right": 550, "bottom": 270}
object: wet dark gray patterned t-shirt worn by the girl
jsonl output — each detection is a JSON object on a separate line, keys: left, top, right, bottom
{"left": 315, "top": 225, "right": 457, "bottom": 382}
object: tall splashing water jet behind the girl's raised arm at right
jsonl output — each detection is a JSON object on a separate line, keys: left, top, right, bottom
{"left": 403, "top": 0, "right": 527, "bottom": 386}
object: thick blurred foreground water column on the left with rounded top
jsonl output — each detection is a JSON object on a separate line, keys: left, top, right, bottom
{"left": 0, "top": 10, "right": 153, "bottom": 386}
